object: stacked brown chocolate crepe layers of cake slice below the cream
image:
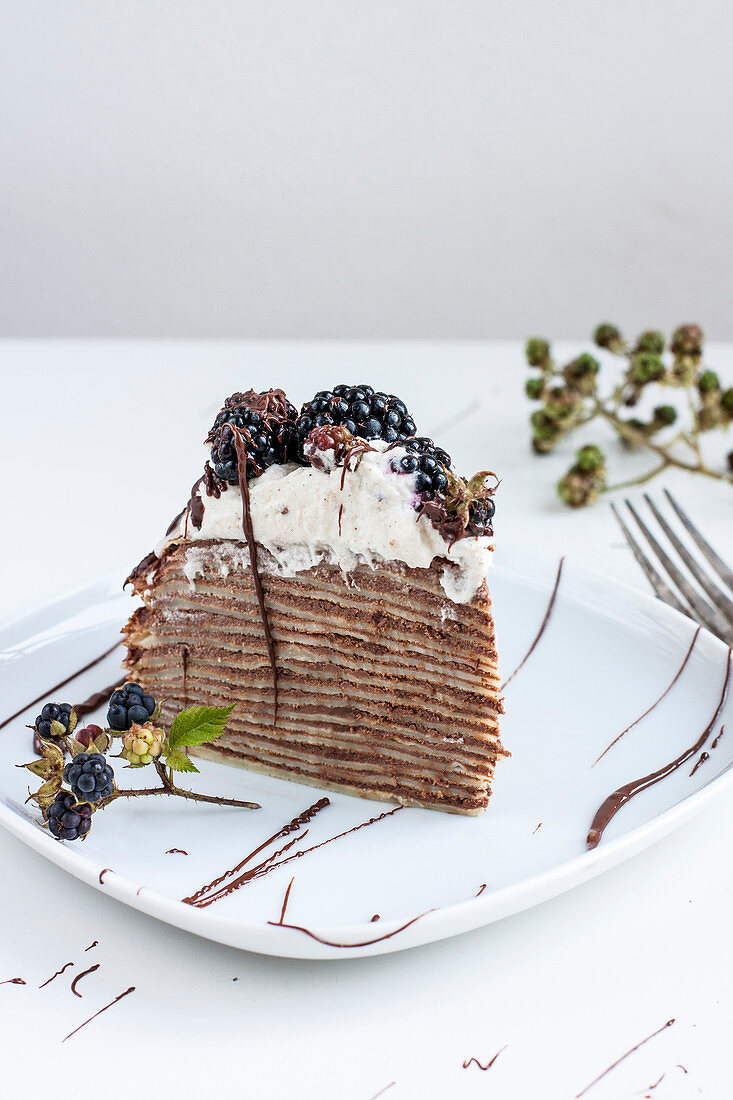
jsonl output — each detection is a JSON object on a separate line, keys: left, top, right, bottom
{"left": 127, "top": 541, "right": 504, "bottom": 814}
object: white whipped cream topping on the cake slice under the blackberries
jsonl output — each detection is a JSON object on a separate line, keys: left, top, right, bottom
{"left": 155, "top": 441, "right": 491, "bottom": 604}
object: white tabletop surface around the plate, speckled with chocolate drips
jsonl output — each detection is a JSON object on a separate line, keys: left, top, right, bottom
{"left": 0, "top": 341, "right": 733, "bottom": 1100}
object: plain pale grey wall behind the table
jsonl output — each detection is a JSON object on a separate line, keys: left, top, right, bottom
{"left": 0, "top": 0, "right": 733, "bottom": 339}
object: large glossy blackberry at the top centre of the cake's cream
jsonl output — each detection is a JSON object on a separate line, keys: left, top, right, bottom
{"left": 293, "top": 385, "right": 415, "bottom": 465}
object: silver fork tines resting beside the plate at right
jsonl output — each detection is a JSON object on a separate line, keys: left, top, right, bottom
{"left": 611, "top": 490, "right": 733, "bottom": 646}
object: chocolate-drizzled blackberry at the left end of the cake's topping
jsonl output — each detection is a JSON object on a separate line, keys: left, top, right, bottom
{"left": 206, "top": 389, "right": 298, "bottom": 485}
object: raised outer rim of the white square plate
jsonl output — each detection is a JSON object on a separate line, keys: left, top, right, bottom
{"left": 0, "top": 554, "right": 733, "bottom": 960}
